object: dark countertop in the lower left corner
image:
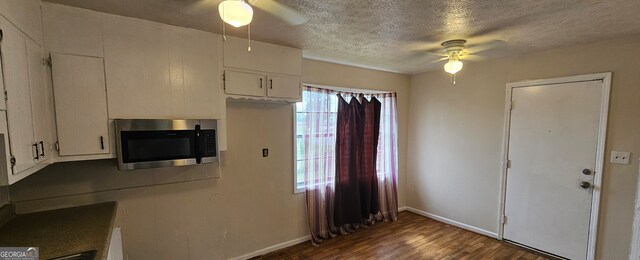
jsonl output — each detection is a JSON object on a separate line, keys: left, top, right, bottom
{"left": 0, "top": 202, "right": 116, "bottom": 259}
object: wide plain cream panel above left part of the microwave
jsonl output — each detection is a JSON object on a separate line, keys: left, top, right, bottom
{"left": 103, "top": 16, "right": 172, "bottom": 118}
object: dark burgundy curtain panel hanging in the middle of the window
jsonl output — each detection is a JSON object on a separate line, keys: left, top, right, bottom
{"left": 334, "top": 96, "right": 381, "bottom": 227}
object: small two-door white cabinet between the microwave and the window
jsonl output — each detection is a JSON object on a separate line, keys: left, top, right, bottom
{"left": 223, "top": 70, "right": 301, "bottom": 102}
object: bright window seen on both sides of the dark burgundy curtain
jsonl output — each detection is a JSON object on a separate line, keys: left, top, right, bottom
{"left": 294, "top": 87, "right": 398, "bottom": 192}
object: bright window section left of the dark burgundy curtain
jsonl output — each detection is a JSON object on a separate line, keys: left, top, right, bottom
{"left": 294, "top": 89, "right": 338, "bottom": 192}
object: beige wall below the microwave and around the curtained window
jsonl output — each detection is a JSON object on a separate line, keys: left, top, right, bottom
{"left": 10, "top": 60, "right": 410, "bottom": 259}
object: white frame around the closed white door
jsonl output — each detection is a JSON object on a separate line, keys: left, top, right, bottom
{"left": 498, "top": 72, "right": 612, "bottom": 260}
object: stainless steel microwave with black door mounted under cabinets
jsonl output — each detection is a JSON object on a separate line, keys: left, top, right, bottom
{"left": 115, "top": 119, "right": 218, "bottom": 170}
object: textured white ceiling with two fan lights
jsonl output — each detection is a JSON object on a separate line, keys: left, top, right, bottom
{"left": 46, "top": 0, "right": 640, "bottom": 74}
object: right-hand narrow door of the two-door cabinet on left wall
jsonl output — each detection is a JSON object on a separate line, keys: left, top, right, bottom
{"left": 26, "top": 39, "right": 53, "bottom": 162}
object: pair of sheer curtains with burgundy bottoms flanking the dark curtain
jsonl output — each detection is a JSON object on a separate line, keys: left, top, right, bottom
{"left": 296, "top": 87, "right": 398, "bottom": 245}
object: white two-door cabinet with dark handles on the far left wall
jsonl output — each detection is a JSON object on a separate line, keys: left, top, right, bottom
{"left": 0, "top": 17, "right": 52, "bottom": 184}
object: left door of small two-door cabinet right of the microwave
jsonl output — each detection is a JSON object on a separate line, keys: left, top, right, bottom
{"left": 224, "top": 71, "right": 266, "bottom": 97}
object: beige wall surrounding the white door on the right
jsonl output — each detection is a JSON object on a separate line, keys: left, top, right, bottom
{"left": 406, "top": 36, "right": 640, "bottom": 259}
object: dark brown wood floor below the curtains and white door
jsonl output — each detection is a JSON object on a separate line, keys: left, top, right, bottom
{"left": 256, "top": 211, "right": 547, "bottom": 259}
